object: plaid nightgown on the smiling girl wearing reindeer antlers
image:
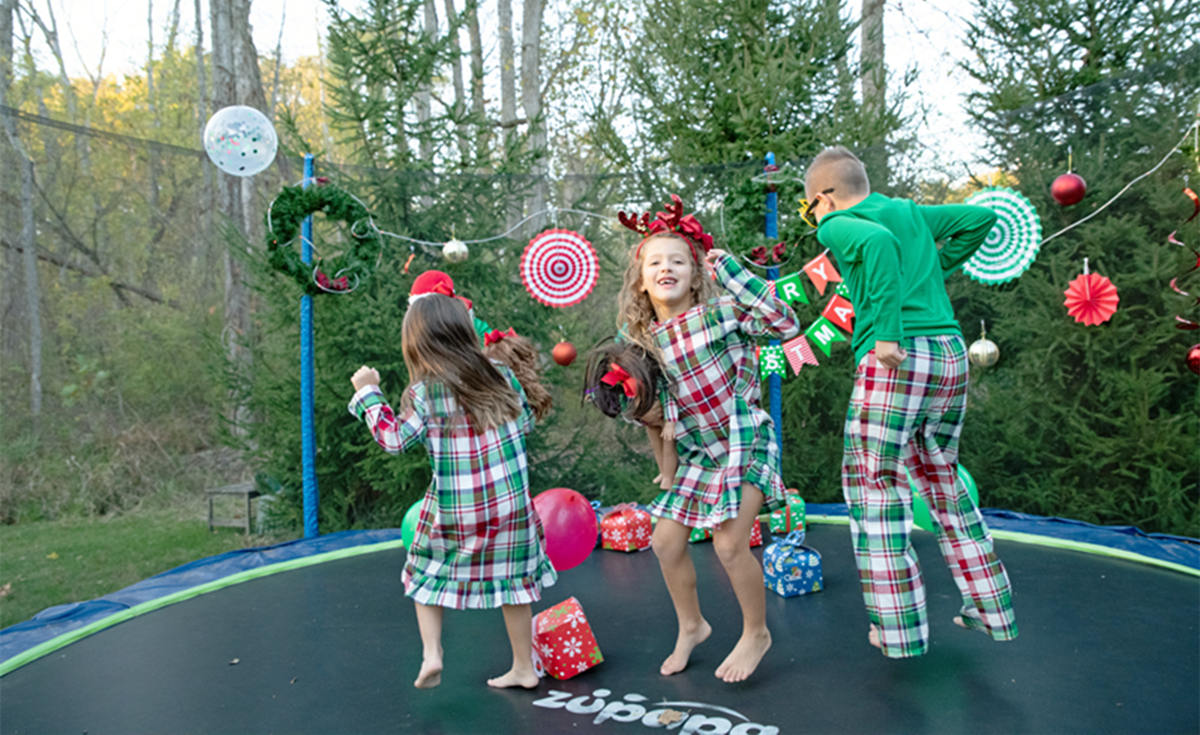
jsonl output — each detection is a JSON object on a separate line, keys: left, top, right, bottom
{"left": 650, "top": 256, "right": 799, "bottom": 527}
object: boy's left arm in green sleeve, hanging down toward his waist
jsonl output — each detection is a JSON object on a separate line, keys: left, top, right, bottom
{"left": 817, "top": 217, "right": 904, "bottom": 348}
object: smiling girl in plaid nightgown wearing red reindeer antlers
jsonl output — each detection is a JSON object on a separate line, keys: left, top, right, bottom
{"left": 617, "top": 195, "right": 799, "bottom": 682}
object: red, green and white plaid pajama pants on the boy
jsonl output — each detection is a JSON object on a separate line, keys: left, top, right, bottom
{"left": 842, "top": 335, "right": 1016, "bottom": 658}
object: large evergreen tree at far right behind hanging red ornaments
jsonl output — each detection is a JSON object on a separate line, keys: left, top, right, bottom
{"left": 952, "top": 0, "right": 1200, "bottom": 536}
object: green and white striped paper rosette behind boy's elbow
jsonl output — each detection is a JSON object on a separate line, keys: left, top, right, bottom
{"left": 962, "top": 187, "right": 1042, "bottom": 285}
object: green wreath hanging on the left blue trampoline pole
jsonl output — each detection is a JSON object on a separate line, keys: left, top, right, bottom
{"left": 266, "top": 179, "right": 379, "bottom": 294}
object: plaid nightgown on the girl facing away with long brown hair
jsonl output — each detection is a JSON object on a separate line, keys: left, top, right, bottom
{"left": 349, "top": 363, "right": 557, "bottom": 610}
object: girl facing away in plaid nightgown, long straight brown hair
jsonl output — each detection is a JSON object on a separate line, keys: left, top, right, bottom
{"left": 349, "top": 294, "right": 556, "bottom": 688}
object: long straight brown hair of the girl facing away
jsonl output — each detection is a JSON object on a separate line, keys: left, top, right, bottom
{"left": 401, "top": 293, "right": 521, "bottom": 431}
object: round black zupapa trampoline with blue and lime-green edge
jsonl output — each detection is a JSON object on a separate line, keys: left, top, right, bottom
{"left": 0, "top": 504, "right": 1200, "bottom": 735}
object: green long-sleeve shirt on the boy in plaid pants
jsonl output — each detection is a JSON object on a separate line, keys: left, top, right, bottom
{"left": 817, "top": 193, "right": 996, "bottom": 360}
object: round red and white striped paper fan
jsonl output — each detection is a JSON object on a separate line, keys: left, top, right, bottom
{"left": 521, "top": 229, "right": 600, "bottom": 309}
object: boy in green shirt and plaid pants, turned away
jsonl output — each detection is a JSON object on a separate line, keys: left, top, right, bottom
{"left": 804, "top": 147, "right": 1016, "bottom": 658}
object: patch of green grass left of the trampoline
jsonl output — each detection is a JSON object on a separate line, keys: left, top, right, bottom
{"left": 0, "top": 510, "right": 285, "bottom": 628}
